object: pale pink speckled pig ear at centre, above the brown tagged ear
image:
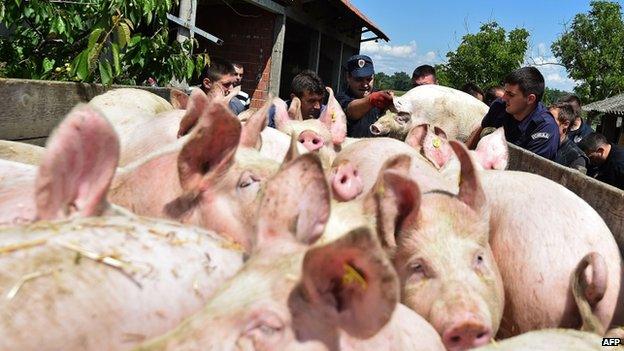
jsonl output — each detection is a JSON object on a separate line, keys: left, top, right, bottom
{"left": 257, "top": 154, "right": 330, "bottom": 247}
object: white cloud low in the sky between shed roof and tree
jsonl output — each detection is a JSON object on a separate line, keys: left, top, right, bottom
{"left": 360, "top": 40, "right": 442, "bottom": 75}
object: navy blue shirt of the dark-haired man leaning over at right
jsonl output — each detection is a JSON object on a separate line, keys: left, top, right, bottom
{"left": 481, "top": 99, "right": 559, "bottom": 161}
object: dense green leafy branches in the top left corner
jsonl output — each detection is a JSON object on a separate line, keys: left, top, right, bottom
{"left": 0, "top": 0, "right": 209, "bottom": 85}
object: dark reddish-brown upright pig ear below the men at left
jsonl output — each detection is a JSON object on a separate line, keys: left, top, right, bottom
{"left": 178, "top": 100, "right": 241, "bottom": 191}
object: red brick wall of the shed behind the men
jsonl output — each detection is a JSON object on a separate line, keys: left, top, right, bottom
{"left": 196, "top": 2, "right": 275, "bottom": 107}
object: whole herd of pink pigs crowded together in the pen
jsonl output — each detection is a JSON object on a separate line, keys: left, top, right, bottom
{"left": 0, "top": 85, "right": 624, "bottom": 351}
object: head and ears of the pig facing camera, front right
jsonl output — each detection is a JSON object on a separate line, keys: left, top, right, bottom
{"left": 381, "top": 141, "right": 505, "bottom": 350}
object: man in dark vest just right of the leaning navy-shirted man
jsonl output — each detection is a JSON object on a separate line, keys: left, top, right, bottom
{"left": 549, "top": 103, "right": 589, "bottom": 173}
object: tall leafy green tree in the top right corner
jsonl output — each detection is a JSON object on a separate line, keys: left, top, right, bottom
{"left": 551, "top": 1, "right": 624, "bottom": 102}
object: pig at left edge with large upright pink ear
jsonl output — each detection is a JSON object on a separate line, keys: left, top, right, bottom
{"left": 0, "top": 104, "right": 119, "bottom": 224}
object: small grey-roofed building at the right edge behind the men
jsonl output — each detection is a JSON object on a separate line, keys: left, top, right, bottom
{"left": 583, "top": 94, "right": 624, "bottom": 145}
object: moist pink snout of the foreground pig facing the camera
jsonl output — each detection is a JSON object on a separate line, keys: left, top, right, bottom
{"left": 442, "top": 316, "right": 492, "bottom": 351}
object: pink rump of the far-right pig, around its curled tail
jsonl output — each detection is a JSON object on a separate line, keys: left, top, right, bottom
{"left": 480, "top": 170, "right": 624, "bottom": 337}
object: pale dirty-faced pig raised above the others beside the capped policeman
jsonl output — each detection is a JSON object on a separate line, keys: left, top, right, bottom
{"left": 371, "top": 85, "right": 488, "bottom": 141}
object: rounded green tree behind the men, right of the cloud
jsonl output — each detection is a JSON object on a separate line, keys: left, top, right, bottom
{"left": 436, "top": 22, "right": 529, "bottom": 89}
